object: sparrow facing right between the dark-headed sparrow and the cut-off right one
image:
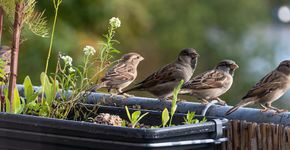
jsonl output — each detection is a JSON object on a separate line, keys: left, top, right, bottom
{"left": 179, "top": 60, "right": 239, "bottom": 104}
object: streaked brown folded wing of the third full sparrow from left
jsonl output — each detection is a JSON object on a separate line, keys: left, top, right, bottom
{"left": 183, "top": 70, "right": 227, "bottom": 90}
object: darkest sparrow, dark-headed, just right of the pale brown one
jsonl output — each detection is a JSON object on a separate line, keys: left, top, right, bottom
{"left": 123, "top": 48, "right": 199, "bottom": 100}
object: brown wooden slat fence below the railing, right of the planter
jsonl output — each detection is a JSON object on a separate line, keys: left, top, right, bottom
{"left": 217, "top": 120, "right": 290, "bottom": 150}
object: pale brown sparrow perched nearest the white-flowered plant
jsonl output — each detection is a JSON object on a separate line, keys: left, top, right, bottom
{"left": 92, "top": 53, "right": 144, "bottom": 93}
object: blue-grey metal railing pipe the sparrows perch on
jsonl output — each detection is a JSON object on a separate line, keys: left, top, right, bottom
{"left": 17, "top": 84, "right": 290, "bottom": 125}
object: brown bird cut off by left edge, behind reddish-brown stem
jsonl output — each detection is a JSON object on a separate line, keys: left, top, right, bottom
{"left": 0, "top": 46, "right": 11, "bottom": 82}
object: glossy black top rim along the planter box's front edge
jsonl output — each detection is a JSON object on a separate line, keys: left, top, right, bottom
{"left": 0, "top": 107, "right": 227, "bottom": 135}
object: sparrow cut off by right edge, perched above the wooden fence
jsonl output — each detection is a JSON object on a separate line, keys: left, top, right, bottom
{"left": 226, "top": 60, "right": 290, "bottom": 115}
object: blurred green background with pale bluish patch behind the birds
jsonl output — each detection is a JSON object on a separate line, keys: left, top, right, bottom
{"left": 3, "top": 0, "right": 290, "bottom": 108}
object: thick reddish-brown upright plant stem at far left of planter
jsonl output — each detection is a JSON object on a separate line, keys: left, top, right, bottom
{"left": 8, "top": 1, "right": 25, "bottom": 112}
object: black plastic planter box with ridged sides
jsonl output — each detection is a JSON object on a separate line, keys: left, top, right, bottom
{"left": 0, "top": 107, "right": 227, "bottom": 150}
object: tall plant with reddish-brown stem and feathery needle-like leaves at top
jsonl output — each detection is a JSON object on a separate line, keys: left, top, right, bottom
{"left": 0, "top": 0, "right": 48, "bottom": 112}
